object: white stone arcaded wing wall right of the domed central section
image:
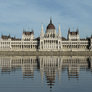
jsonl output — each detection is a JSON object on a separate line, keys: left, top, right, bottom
{"left": 62, "top": 40, "right": 88, "bottom": 51}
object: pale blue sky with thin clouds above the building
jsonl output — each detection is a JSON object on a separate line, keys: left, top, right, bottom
{"left": 0, "top": 0, "right": 92, "bottom": 38}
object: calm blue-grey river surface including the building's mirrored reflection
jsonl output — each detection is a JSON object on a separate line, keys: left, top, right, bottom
{"left": 0, "top": 56, "right": 92, "bottom": 92}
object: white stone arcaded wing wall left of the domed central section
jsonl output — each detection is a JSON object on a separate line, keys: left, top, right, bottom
{"left": 0, "top": 39, "right": 38, "bottom": 51}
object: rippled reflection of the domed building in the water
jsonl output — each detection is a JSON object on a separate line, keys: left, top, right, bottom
{"left": 0, "top": 56, "right": 92, "bottom": 88}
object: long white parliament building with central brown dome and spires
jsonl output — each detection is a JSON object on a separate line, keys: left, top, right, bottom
{"left": 0, "top": 19, "right": 92, "bottom": 51}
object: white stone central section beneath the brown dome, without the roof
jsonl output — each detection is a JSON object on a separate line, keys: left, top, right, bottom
{"left": 40, "top": 27, "right": 62, "bottom": 51}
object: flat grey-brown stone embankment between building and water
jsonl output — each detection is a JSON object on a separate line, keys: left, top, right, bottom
{"left": 0, "top": 51, "right": 92, "bottom": 56}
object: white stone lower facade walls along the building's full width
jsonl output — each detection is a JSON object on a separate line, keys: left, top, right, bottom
{"left": 0, "top": 38, "right": 92, "bottom": 51}
